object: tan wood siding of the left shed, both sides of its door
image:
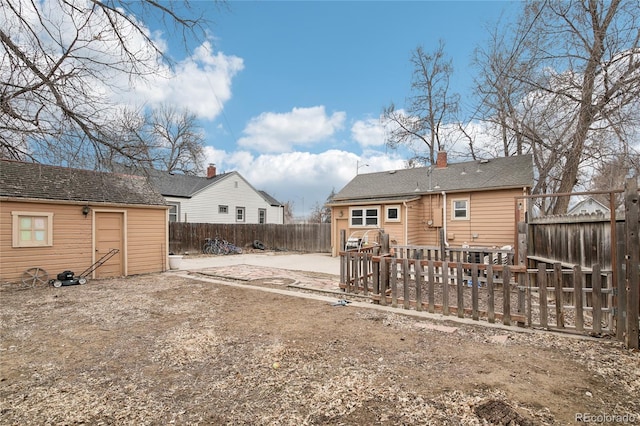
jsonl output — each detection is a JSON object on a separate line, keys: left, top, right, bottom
{"left": 0, "top": 201, "right": 168, "bottom": 282}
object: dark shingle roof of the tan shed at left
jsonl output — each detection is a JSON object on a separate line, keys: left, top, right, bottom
{"left": 0, "top": 160, "right": 166, "bottom": 205}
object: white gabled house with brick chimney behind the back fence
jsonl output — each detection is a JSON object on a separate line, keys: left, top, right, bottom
{"left": 148, "top": 165, "right": 284, "bottom": 224}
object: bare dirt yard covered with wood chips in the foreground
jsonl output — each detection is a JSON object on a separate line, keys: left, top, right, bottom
{"left": 0, "top": 270, "right": 640, "bottom": 425}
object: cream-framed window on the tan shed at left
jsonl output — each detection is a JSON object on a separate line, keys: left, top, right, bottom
{"left": 11, "top": 212, "right": 53, "bottom": 247}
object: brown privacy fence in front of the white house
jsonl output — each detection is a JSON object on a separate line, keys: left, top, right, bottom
{"left": 169, "top": 222, "right": 331, "bottom": 253}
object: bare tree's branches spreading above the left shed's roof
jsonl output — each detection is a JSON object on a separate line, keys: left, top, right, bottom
{"left": 0, "top": 0, "right": 212, "bottom": 170}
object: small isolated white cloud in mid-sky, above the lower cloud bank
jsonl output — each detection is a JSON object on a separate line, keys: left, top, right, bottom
{"left": 238, "top": 106, "right": 346, "bottom": 153}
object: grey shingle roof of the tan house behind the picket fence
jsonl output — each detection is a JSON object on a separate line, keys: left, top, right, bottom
{"left": 333, "top": 155, "right": 533, "bottom": 203}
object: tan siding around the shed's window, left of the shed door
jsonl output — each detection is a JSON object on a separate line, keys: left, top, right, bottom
{"left": 0, "top": 202, "right": 92, "bottom": 282}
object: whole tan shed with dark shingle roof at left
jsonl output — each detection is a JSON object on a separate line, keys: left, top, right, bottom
{"left": 0, "top": 160, "right": 168, "bottom": 282}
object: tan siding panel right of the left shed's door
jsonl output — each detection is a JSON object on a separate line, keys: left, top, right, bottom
{"left": 127, "top": 209, "right": 169, "bottom": 275}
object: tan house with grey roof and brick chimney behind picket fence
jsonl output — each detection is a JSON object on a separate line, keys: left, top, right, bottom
{"left": 330, "top": 152, "right": 533, "bottom": 256}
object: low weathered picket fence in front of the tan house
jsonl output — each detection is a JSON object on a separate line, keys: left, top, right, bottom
{"left": 340, "top": 247, "right": 615, "bottom": 335}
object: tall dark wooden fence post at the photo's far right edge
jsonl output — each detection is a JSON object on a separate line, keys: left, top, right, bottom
{"left": 625, "top": 176, "right": 640, "bottom": 349}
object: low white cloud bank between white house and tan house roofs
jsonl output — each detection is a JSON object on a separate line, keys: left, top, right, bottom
{"left": 205, "top": 147, "right": 404, "bottom": 215}
